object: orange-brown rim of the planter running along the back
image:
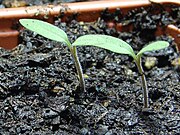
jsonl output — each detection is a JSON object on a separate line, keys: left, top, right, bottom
{"left": 0, "top": 0, "right": 180, "bottom": 19}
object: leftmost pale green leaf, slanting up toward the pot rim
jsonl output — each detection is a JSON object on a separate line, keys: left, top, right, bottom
{"left": 19, "top": 19, "right": 71, "bottom": 46}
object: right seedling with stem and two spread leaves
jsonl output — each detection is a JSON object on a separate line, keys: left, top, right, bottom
{"left": 73, "top": 35, "right": 169, "bottom": 108}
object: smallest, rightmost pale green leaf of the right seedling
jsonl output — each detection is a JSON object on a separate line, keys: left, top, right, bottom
{"left": 137, "top": 41, "right": 169, "bottom": 56}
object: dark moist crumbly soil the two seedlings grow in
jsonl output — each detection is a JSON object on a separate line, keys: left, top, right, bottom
{"left": 0, "top": 4, "right": 180, "bottom": 135}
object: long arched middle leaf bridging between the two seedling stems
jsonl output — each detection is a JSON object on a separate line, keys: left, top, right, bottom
{"left": 72, "top": 35, "right": 136, "bottom": 58}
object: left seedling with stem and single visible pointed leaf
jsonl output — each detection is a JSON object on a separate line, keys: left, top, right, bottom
{"left": 19, "top": 19, "right": 85, "bottom": 92}
